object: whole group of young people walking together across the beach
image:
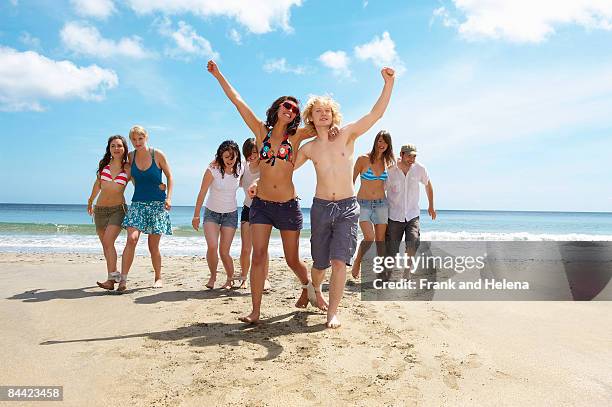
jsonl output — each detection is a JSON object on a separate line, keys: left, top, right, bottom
{"left": 88, "top": 61, "right": 436, "bottom": 328}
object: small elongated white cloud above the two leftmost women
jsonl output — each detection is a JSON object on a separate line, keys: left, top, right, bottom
{"left": 60, "top": 22, "right": 153, "bottom": 59}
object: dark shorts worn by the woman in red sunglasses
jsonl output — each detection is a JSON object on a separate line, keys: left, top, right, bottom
{"left": 249, "top": 197, "right": 303, "bottom": 230}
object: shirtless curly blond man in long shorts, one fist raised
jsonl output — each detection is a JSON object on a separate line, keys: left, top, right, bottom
{"left": 295, "top": 68, "right": 395, "bottom": 328}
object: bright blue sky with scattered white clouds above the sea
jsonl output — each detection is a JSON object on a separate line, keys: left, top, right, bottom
{"left": 0, "top": 0, "right": 612, "bottom": 212}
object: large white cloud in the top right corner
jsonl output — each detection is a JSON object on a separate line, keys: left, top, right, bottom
{"left": 434, "top": 0, "right": 612, "bottom": 43}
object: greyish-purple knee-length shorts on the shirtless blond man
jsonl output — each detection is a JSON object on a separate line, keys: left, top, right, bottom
{"left": 310, "top": 197, "right": 359, "bottom": 270}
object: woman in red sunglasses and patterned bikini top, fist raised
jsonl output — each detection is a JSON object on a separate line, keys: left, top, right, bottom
{"left": 208, "top": 61, "right": 314, "bottom": 324}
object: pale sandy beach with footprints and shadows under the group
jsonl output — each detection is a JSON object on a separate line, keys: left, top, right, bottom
{"left": 0, "top": 253, "right": 612, "bottom": 406}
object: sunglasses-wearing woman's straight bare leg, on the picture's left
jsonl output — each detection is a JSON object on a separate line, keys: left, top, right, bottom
{"left": 239, "top": 223, "right": 272, "bottom": 324}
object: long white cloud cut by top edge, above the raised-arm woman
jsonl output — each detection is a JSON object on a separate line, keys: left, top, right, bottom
{"left": 128, "top": 0, "right": 302, "bottom": 34}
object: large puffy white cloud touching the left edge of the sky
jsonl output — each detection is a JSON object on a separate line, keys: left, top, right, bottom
{"left": 0, "top": 47, "right": 119, "bottom": 111}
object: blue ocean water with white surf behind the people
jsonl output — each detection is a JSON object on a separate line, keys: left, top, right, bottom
{"left": 0, "top": 203, "right": 612, "bottom": 257}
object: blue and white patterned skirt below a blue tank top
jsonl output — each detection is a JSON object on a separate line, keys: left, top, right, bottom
{"left": 122, "top": 201, "right": 172, "bottom": 235}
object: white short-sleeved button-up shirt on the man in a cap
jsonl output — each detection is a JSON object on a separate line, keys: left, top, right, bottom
{"left": 385, "top": 162, "right": 429, "bottom": 222}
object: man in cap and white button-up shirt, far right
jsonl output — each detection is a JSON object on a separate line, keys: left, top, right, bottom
{"left": 385, "top": 144, "right": 436, "bottom": 262}
